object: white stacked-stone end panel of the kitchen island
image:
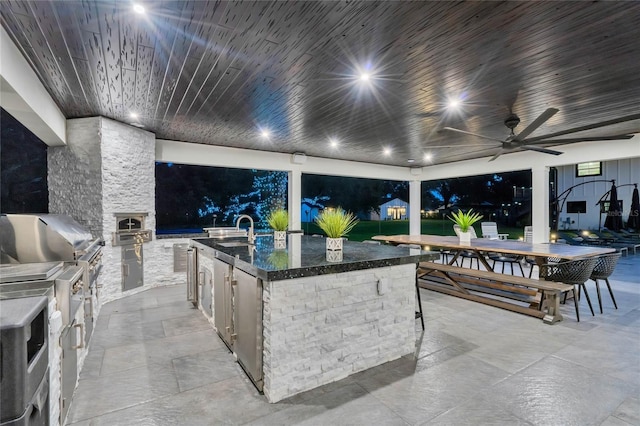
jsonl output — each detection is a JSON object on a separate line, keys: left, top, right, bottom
{"left": 263, "top": 264, "right": 416, "bottom": 402}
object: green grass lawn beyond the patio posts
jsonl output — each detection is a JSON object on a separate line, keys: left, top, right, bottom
{"left": 302, "top": 219, "right": 524, "bottom": 241}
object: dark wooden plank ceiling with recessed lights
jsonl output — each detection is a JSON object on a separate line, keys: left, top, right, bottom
{"left": 0, "top": 0, "right": 640, "bottom": 168}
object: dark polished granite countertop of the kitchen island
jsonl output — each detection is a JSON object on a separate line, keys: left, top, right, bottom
{"left": 192, "top": 234, "right": 439, "bottom": 281}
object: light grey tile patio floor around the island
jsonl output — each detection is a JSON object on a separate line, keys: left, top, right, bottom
{"left": 68, "top": 256, "right": 640, "bottom": 426}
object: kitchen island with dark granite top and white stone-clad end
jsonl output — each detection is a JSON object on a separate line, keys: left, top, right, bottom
{"left": 188, "top": 234, "right": 438, "bottom": 402}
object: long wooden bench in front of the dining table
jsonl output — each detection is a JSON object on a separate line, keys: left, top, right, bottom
{"left": 418, "top": 262, "right": 575, "bottom": 323}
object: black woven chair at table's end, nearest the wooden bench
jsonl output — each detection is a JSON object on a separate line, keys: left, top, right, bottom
{"left": 540, "top": 257, "right": 598, "bottom": 322}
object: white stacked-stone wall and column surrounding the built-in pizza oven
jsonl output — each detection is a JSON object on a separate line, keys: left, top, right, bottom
{"left": 48, "top": 117, "right": 188, "bottom": 304}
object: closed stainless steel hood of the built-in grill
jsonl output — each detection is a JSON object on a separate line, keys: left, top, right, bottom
{"left": 0, "top": 214, "right": 92, "bottom": 263}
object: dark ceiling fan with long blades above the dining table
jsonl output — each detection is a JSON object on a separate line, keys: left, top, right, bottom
{"left": 443, "top": 108, "right": 640, "bottom": 161}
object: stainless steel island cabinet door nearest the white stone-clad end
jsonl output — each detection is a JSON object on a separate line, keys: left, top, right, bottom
{"left": 233, "top": 269, "right": 262, "bottom": 390}
